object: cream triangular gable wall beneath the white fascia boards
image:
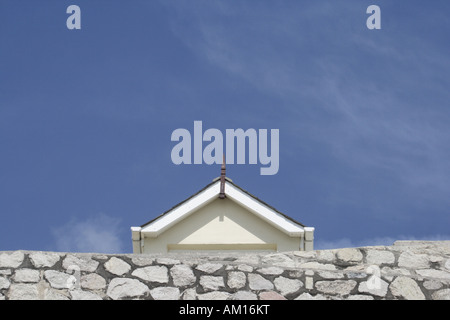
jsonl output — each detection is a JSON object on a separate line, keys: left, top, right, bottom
{"left": 150, "top": 198, "right": 300, "bottom": 252}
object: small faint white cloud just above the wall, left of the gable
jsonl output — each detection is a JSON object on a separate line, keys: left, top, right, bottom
{"left": 52, "top": 213, "right": 124, "bottom": 253}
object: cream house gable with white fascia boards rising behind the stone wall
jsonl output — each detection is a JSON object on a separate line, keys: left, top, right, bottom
{"left": 132, "top": 178, "right": 313, "bottom": 252}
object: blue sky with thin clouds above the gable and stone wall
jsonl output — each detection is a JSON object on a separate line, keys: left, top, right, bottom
{"left": 0, "top": 0, "right": 450, "bottom": 252}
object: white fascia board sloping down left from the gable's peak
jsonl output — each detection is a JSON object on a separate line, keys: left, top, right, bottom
{"left": 141, "top": 181, "right": 220, "bottom": 238}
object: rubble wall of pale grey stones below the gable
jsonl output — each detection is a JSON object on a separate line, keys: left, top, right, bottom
{"left": 0, "top": 241, "right": 450, "bottom": 300}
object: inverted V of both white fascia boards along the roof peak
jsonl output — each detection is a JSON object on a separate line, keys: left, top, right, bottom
{"left": 141, "top": 179, "right": 305, "bottom": 237}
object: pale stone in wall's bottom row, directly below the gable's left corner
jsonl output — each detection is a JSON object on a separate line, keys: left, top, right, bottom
{"left": 106, "top": 278, "right": 150, "bottom": 300}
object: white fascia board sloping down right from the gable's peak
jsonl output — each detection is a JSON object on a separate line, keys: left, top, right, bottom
{"left": 225, "top": 183, "right": 304, "bottom": 237}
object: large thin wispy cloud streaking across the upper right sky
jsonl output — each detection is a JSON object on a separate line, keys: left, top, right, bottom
{"left": 165, "top": 1, "right": 450, "bottom": 210}
